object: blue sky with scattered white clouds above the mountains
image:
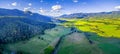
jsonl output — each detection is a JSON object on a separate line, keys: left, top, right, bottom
{"left": 0, "top": 0, "right": 120, "bottom": 16}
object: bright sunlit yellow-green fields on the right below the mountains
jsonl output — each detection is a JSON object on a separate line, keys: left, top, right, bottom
{"left": 61, "top": 18, "right": 120, "bottom": 38}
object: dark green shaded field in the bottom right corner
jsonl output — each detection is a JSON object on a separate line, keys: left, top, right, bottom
{"left": 88, "top": 33, "right": 120, "bottom": 54}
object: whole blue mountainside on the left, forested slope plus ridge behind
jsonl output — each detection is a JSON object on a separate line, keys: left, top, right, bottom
{"left": 0, "top": 9, "right": 56, "bottom": 43}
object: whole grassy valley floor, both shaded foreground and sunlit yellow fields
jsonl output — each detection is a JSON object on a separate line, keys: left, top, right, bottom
{"left": 3, "top": 18, "right": 120, "bottom": 54}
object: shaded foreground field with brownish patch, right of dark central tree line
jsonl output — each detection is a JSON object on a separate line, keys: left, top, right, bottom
{"left": 58, "top": 27, "right": 120, "bottom": 54}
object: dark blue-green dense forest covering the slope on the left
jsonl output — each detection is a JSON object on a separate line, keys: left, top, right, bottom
{"left": 0, "top": 18, "right": 55, "bottom": 43}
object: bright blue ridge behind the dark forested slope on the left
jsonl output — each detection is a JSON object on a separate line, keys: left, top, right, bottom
{"left": 0, "top": 8, "right": 51, "bottom": 22}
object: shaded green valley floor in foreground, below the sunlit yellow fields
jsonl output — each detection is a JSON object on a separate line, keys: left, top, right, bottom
{"left": 1, "top": 26, "right": 120, "bottom": 54}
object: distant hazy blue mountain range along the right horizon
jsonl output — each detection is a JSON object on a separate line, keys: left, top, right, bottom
{"left": 58, "top": 11, "right": 120, "bottom": 18}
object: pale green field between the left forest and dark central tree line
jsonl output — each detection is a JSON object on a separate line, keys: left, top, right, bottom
{"left": 5, "top": 26, "right": 70, "bottom": 54}
